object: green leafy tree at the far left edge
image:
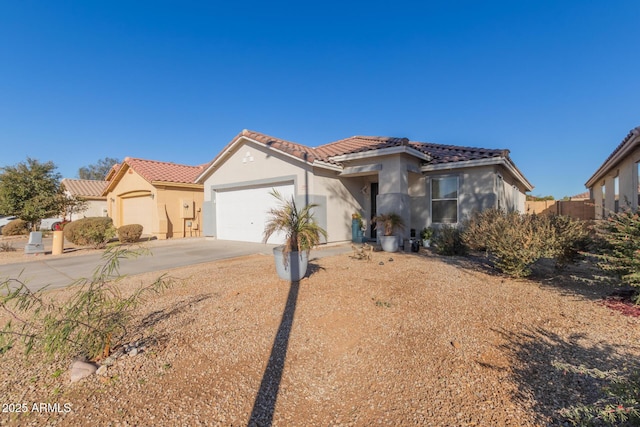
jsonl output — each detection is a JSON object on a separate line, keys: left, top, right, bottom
{"left": 0, "top": 157, "right": 64, "bottom": 229}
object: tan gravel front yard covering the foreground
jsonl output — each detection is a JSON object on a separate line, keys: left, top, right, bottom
{"left": 0, "top": 246, "right": 640, "bottom": 426}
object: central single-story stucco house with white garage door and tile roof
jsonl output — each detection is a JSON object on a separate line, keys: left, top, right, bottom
{"left": 196, "top": 130, "right": 533, "bottom": 243}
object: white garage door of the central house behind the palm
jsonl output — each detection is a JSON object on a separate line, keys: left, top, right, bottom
{"left": 216, "top": 184, "right": 293, "bottom": 244}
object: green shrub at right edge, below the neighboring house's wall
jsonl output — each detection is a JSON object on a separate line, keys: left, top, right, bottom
{"left": 596, "top": 210, "right": 640, "bottom": 304}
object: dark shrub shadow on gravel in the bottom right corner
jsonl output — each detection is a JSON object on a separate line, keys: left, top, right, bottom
{"left": 496, "top": 328, "right": 640, "bottom": 425}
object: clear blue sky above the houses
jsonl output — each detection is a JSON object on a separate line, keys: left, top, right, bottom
{"left": 0, "top": 0, "right": 640, "bottom": 198}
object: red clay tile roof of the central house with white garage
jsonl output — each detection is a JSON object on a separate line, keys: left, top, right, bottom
{"left": 225, "top": 129, "right": 509, "bottom": 164}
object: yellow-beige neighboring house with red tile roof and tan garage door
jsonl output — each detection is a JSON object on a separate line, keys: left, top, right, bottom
{"left": 102, "top": 157, "right": 204, "bottom": 239}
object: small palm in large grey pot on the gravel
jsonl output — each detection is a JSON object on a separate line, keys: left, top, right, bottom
{"left": 262, "top": 189, "right": 327, "bottom": 282}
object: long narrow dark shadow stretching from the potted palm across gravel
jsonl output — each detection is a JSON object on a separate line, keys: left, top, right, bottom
{"left": 248, "top": 282, "right": 300, "bottom": 427}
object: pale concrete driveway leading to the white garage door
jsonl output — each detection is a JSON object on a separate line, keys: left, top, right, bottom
{"left": 0, "top": 237, "right": 351, "bottom": 290}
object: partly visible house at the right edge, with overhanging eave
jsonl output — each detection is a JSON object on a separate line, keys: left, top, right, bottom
{"left": 585, "top": 126, "right": 640, "bottom": 218}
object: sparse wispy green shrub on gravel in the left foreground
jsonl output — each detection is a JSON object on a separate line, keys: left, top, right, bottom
{"left": 0, "top": 247, "right": 171, "bottom": 360}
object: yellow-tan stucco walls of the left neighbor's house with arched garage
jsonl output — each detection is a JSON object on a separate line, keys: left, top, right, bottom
{"left": 107, "top": 169, "right": 203, "bottom": 239}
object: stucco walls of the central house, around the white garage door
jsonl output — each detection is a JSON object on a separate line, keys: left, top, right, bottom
{"left": 204, "top": 142, "right": 525, "bottom": 242}
